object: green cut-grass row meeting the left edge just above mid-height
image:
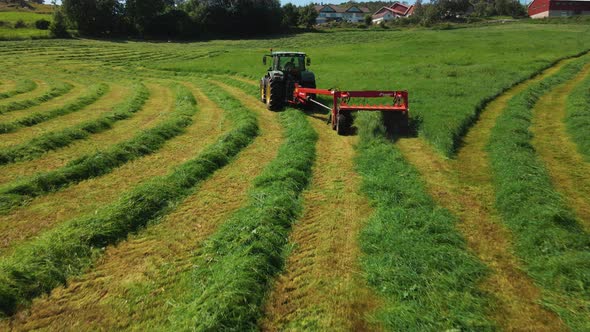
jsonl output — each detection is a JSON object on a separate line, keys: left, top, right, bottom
{"left": 0, "top": 84, "right": 149, "bottom": 165}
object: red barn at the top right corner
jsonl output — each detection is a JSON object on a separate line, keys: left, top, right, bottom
{"left": 528, "top": 0, "right": 590, "bottom": 18}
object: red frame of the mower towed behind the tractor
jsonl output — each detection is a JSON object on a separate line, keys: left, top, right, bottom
{"left": 292, "top": 84, "right": 409, "bottom": 129}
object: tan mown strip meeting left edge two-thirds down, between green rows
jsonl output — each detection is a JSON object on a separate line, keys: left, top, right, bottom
{"left": 0, "top": 82, "right": 228, "bottom": 256}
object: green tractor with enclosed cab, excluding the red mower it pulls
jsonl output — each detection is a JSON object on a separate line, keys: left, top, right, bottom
{"left": 260, "top": 50, "right": 316, "bottom": 111}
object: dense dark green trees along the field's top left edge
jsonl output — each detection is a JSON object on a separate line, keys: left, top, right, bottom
{"left": 52, "top": 0, "right": 317, "bottom": 39}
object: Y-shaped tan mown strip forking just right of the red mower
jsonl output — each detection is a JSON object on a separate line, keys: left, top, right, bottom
{"left": 397, "top": 60, "right": 567, "bottom": 331}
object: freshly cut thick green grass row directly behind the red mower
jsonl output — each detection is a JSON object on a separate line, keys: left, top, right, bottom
{"left": 356, "top": 113, "right": 496, "bottom": 331}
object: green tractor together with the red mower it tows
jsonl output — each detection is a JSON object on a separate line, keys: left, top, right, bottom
{"left": 260, "top": 50, "right": 409, "bottom": 135}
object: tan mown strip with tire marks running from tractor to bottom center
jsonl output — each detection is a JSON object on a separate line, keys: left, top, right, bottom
{"left": 262, "top": 111, "right": 377, "bottom": 331}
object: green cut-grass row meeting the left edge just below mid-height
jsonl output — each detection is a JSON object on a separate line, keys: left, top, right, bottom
{"left": 0, "top": 82, "right": 196, "bottom": 213}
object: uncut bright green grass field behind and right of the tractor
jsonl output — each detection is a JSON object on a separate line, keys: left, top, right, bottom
{"left": 154, "top": 24, "right": 590, "bottom": 154}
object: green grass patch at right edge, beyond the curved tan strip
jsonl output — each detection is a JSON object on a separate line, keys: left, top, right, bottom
{"left": 565, "top": 73, "right": 590, "bottom": 162}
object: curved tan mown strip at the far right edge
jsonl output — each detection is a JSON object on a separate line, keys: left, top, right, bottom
{"left": 531, "top": 65, "right": 590, "bottom": 231}
